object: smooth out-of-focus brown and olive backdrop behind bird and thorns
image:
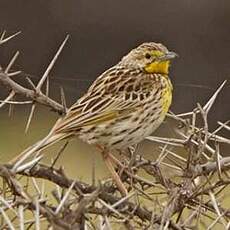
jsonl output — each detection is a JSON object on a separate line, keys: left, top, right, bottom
{"left": 0, "top": 0, "right": 230, "bottom": 179}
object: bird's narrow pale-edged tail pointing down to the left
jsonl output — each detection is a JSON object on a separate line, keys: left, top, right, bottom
{"left": 9, "top": 130, "right": 69, "bottom": 168}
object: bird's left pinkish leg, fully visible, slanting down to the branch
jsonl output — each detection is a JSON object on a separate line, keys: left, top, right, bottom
{"left": 99, "top": 146, "right": 128, "bottom": 196}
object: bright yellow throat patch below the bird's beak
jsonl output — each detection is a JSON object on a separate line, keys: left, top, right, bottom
{"left": 145, "top": 60, "right": 170, "bottom": 74}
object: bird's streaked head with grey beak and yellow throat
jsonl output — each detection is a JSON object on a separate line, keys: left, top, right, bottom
{"left": 120, "top": 42, "right": 177, "bottom": 74}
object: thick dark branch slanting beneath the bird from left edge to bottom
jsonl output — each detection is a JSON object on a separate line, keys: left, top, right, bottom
{"left": 0, "top": 164, "right": 182, "bottom": 230}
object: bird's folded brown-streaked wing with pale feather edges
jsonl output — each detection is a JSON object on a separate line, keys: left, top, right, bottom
{"left": 55, "top": 67, "right": 156, "bottom": 132}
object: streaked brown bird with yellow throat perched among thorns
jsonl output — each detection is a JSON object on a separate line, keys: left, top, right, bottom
{"left": 11, "top": 42, "right": 177, "bottom": 196}
